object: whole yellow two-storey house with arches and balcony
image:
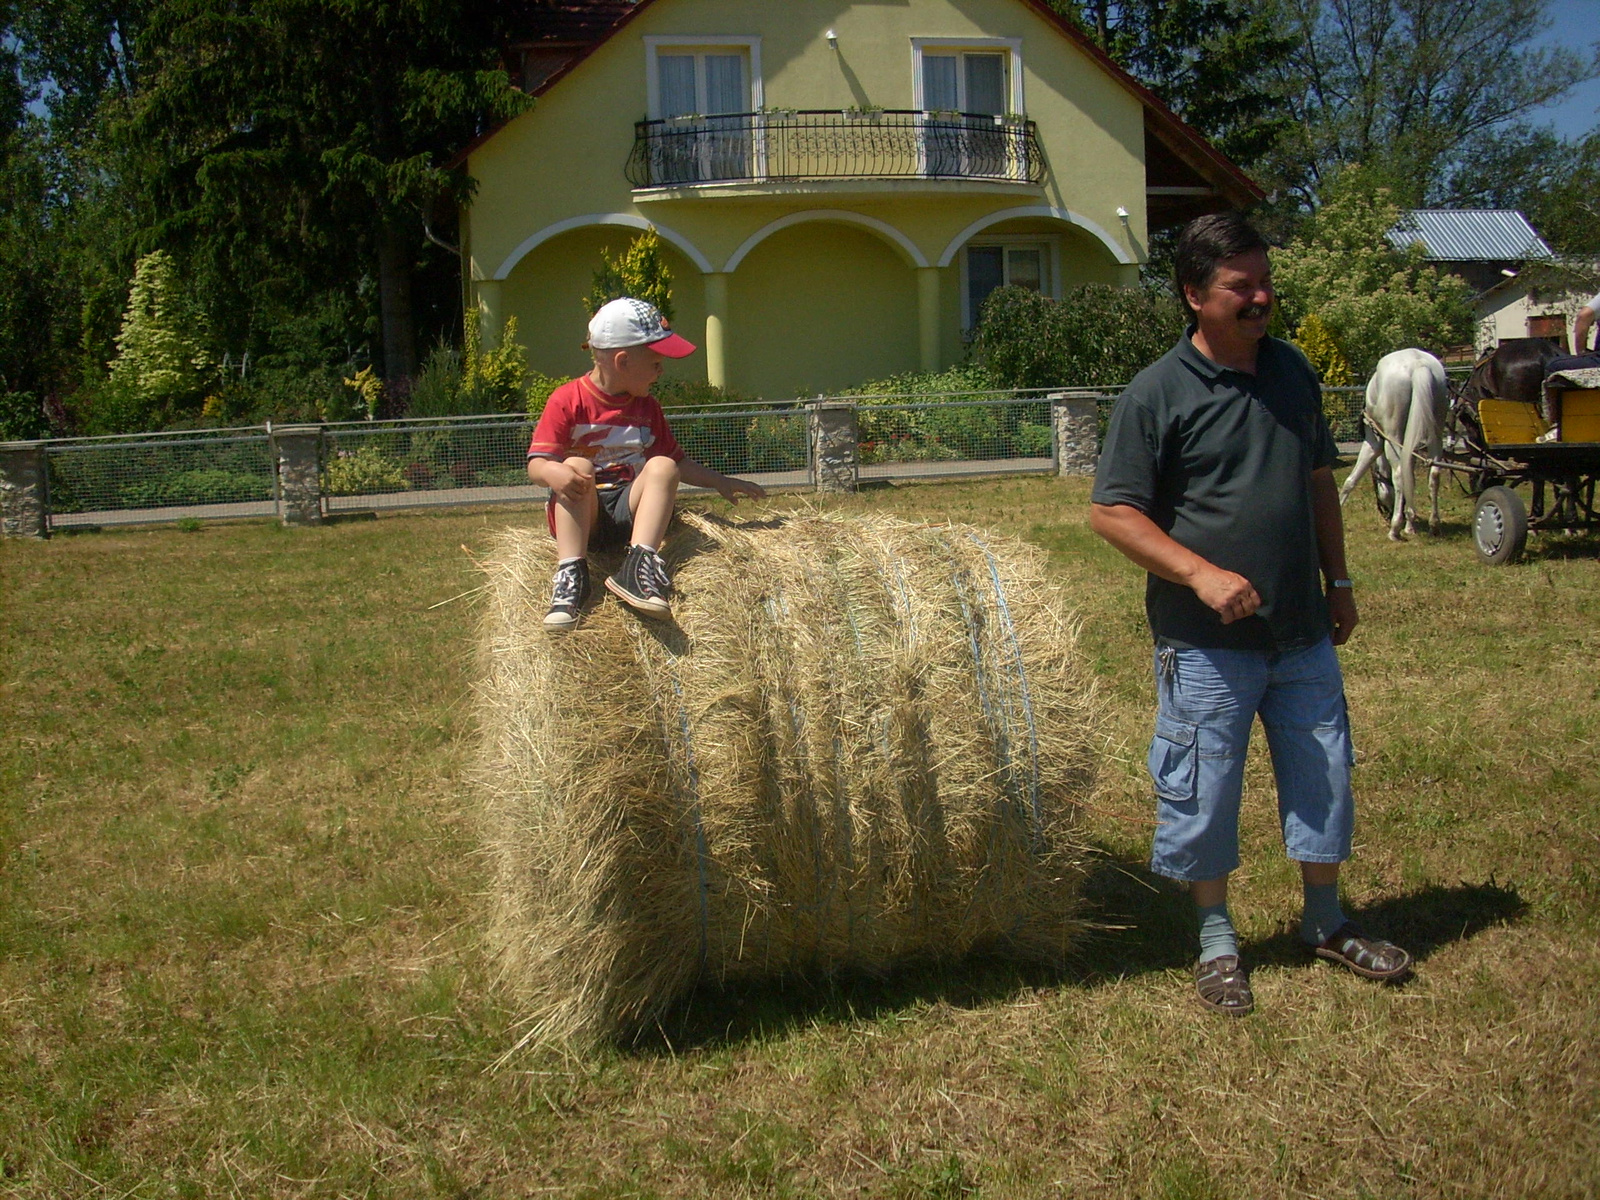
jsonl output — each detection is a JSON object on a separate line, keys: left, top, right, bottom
{"left": 458, "top": 0, "right": 1261, "bottom": 398}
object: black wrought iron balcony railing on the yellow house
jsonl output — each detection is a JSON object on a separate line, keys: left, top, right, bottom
{"left": 624, "top": 109, "right": 1045, "bottom": 189}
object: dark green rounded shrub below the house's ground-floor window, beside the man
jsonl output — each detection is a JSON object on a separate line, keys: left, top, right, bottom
{"left": 973, "top": 283, "right": 1184, "bottom": 387}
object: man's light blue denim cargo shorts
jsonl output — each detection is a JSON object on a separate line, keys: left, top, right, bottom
{"left": 1149, "top": 640, "right": 1355, "bottom": 883}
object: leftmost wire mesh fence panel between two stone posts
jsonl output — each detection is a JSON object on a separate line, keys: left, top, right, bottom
{"left": 45, "top": 429, "right": 277, "bottom": 526}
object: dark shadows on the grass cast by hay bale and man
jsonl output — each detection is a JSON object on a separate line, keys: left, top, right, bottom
{"left": 629, "top": 851, "right": 1528, "bottom": 1058}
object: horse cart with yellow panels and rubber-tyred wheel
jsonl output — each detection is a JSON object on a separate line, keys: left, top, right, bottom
{"left": 1459, "top": 370, "right": 1600, "bottom": 565}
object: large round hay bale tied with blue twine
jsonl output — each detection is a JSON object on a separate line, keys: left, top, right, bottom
{"left": 478, "top": 512, "right": 1098, "bottom": 1042}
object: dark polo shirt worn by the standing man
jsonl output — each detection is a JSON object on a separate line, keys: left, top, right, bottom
{"left": 1093, "top": 328, "right": 1338, "bottom": 651}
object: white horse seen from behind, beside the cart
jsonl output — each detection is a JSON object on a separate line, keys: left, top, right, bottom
{"left": 1339, "top": 350, "right": 1450, "bottom": 541}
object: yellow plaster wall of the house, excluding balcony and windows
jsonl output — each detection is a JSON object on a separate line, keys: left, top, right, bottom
{"left": 464, "top": 0, "right": 1146, "bottom": 394}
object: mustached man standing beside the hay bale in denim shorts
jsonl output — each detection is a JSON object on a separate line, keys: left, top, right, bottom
{"left": 1090, "top": 213, "right": 1411, "bottom": 1016}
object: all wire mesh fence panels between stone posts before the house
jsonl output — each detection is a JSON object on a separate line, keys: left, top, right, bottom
{"left": 15, "top": 387, "right": 1388, "bottom": 528}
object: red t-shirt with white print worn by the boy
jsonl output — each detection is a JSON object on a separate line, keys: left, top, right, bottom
{"left": 528, "top": 374, "right": 683, "bottom": 483}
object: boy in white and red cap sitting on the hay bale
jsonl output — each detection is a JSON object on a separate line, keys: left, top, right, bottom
{"left": 528, "top": 296, "right": 766, "bottom": 629}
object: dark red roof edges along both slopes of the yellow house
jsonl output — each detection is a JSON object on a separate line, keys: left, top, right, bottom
{"left": 448, "top": 0, "right": 1266, "bottom": 208}
